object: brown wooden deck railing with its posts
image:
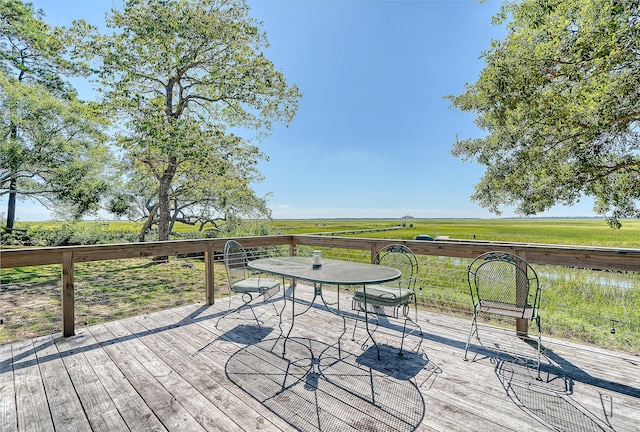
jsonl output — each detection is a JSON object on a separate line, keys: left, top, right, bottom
{"left": 0, "top": 235, "right": 640, "bottom": 336}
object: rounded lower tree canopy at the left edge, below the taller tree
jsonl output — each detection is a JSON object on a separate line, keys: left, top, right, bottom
{"left": 0, "top": 72, "right": 109, "bottom": 218}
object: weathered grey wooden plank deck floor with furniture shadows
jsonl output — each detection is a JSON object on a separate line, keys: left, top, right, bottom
{"left": 0, "top": 290, "right": 640, "bottom": 432}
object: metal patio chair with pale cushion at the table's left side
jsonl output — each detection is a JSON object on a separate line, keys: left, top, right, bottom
{"left": 216, "top": 240, "right": 280, "bottom": 328}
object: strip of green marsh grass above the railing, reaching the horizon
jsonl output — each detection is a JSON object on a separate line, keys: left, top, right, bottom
{"left": 12, "top": 218, "right": 640, "bottom": 248}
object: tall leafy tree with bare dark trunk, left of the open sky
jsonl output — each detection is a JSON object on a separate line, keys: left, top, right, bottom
{"left": 77, "top": 0, "right": 300, "bottom": 240}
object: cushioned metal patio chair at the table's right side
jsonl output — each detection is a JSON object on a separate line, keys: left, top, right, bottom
{"left": 352, "top": 244, "right": 422, "bottom": 359}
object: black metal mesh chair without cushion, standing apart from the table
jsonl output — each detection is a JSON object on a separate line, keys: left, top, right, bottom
{"left": 464, "top": 252, "right": 541, "bottom": 379}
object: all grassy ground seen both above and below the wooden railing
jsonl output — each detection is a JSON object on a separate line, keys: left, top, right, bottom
{"left": 0, "top": 219, "right": 640, "bottom": 354}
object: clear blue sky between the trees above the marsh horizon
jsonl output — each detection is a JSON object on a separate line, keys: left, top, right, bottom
{"left": 5, "top": 0, "right": 594, "bottom": 221}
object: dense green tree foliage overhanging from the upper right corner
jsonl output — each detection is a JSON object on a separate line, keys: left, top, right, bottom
{"left": 449, "top": 0, "right": 640, "bottom": 227}
